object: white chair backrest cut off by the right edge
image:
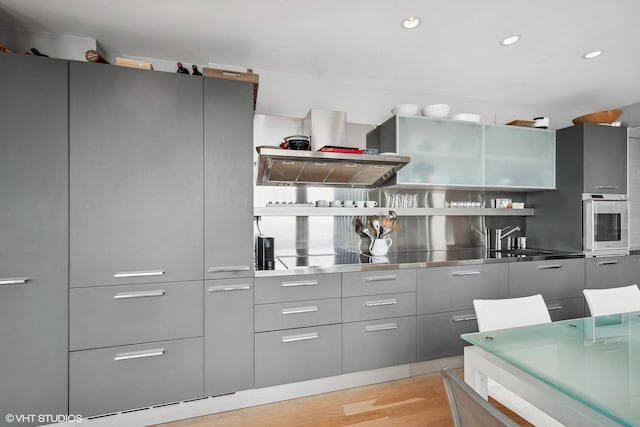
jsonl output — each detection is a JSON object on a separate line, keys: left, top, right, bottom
{"left": 582, "top": 285, "right": 640, "bottom": 316}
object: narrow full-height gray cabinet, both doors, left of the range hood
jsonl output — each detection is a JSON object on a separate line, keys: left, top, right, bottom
{"left": 204, "top": 78, "right": 254, "bottom": 395}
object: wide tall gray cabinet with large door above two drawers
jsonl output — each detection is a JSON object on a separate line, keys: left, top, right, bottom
{"left": 69, "top": 62, "right": 204, "bottom": 415}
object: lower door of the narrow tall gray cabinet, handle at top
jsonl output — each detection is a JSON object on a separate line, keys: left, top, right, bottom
{"left": 204, "top": 277, "right": 254, "bottom": 396}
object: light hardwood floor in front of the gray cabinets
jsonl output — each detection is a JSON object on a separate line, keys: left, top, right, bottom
{"left": 150, "top": 370, "right": 531, "bottom": 427}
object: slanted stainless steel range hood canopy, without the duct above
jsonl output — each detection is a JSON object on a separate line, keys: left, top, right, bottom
{"left": 256, "top": 148, "right": 409, "bottom": 187}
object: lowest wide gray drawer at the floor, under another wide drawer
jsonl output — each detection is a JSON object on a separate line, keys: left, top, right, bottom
{"left": 69, "top": 338, "right": 203, "bottom": 416}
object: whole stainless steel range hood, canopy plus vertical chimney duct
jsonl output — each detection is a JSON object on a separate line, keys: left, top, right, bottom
{"left": 256, "top": 110, "right": 409, "bottom": 187}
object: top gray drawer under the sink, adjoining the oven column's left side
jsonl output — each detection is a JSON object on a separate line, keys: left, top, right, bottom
{"left": 509, "top": 259, "right": 585, "bottom": 301}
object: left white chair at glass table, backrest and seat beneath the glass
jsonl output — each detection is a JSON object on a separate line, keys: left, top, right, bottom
{"left": 473, "top": 294, "right": 563, "bottom": 426}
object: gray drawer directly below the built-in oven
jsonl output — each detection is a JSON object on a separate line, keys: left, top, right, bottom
{"left": 585, "top": 255, "right": 640, "bottom": 289}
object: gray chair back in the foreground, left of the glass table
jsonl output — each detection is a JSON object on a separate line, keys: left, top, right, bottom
{"left": 441, "top": 368, "right": 518, "bottom": 427}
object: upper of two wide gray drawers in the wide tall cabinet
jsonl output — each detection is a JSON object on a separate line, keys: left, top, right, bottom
{"left": 69, "top": 282, "right": 203, "bottom": 351}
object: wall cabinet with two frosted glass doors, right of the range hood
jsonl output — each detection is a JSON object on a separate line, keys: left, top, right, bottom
{"left": 376, "top": 116, "right": 555, "bottom": 191}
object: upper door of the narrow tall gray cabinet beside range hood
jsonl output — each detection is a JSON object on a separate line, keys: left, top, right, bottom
{"left": 204, "top": 78, "right": 253, "bottom": 279}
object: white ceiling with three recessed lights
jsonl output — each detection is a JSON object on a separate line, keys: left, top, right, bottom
{"left": 0, "top": 0, "right": 640, "bottom": 111}
